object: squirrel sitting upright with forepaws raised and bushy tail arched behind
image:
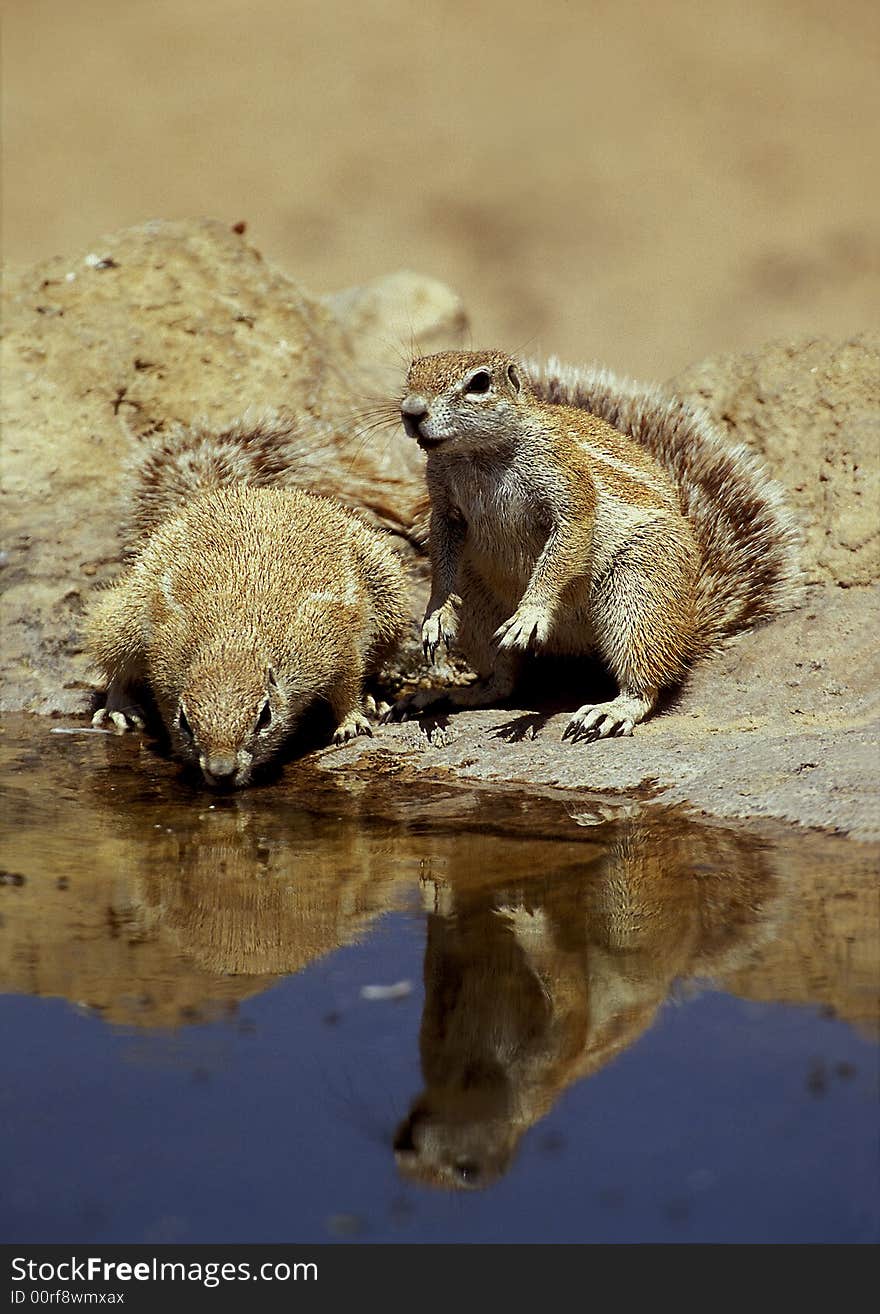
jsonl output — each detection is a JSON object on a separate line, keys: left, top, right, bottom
{"left": 391, "top": 351, "right": 799, "bottom": 740}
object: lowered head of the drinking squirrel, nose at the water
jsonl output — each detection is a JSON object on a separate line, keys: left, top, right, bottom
{"left": 167, "top": 650, "right": 301, "bottom": 788}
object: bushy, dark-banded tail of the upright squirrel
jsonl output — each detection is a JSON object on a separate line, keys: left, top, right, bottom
{"left": 524, "top": 359, "right": 800, "bottom": 648}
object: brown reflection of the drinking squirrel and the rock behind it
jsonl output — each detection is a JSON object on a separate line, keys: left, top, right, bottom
{"left": 0, "top": 736, "right": 418, "bottom": 1028}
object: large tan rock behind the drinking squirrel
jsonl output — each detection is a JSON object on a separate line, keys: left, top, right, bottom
{"left": 0, "top": 219, "right": 464, "bottom": 712}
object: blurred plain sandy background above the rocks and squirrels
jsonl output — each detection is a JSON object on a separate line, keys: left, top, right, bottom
{"left": 3, "top": 0, "right": 880, "bottom": 377}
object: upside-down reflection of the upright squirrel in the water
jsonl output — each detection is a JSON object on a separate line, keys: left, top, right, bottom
{"left": 394, "top": 820, "right": 776, "bottom": 1188}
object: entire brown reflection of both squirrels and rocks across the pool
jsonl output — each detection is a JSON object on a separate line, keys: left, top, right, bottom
{"left": 0, "top": 723, "right": 880, "bottom": 1187}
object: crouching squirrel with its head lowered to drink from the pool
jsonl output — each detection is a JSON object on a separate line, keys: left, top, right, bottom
{"left": 87, "top": 422, "right": 408, "bottom": 787}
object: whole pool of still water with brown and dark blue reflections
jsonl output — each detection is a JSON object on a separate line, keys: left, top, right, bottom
{"left": 0, "top": 719, "right": 880, "bottom": 1243}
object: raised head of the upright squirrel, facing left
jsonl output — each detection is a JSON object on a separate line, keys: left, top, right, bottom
{"left": 401, "top": 351, "right": 532, "bottom": 452}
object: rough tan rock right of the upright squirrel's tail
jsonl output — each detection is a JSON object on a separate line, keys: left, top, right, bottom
{"left": 669, "top": 332, "right": 880, "bottom": 586}
